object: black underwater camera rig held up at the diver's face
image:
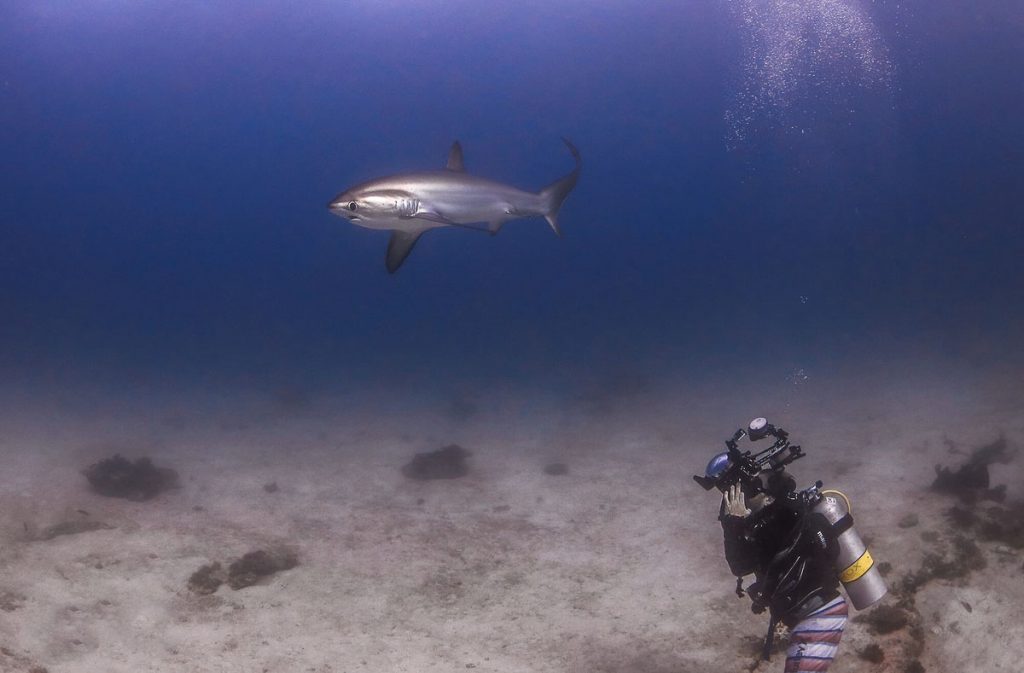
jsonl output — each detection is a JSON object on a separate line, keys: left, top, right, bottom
{"left": 693, "top": 418, "right": 806, "bottom": 495}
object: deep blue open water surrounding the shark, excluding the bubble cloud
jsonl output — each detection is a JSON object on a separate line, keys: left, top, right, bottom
{"left": 0, "top": 0, "right": 1024, "bottom": 393}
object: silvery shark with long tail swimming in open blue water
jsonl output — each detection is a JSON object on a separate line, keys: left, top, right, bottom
{"left": 328, "top": 140, "right": 581, "bottom": 274}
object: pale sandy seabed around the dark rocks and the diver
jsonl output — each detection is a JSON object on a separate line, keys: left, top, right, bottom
{"left": 0, "top": 372, "right": 1024, "bottom": 673}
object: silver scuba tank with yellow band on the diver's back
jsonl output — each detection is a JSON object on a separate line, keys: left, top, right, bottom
{"left": 811, "top": 481, "right": 889, "bottom": 609}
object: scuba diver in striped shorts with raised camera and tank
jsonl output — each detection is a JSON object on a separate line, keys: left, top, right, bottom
{"left": 693, "top": 418, "right": 887, "bottom": 673}
